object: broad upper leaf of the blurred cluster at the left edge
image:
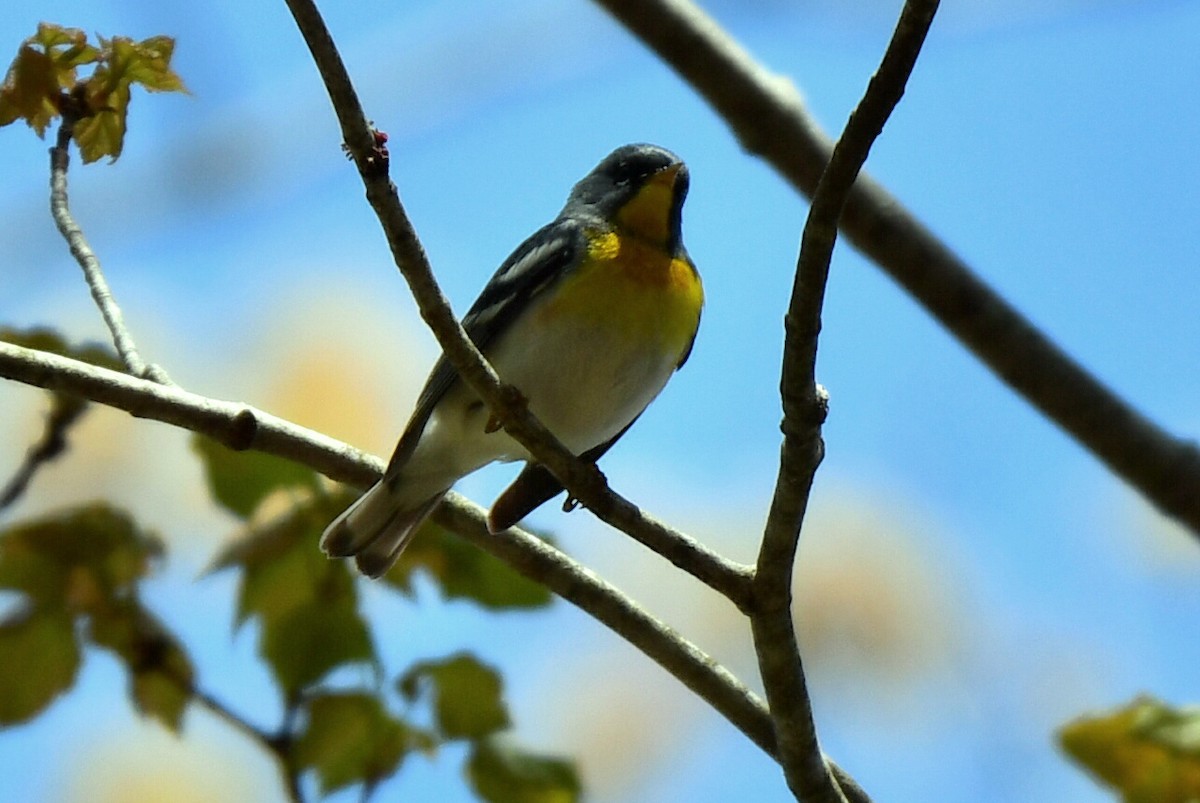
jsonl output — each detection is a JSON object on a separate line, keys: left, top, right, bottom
{"left": 0, "top": 502, "right": 162, "bottom": 612}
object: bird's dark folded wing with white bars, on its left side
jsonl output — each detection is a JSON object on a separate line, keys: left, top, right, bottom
{"left": 386, "top": 217, "right": 586, "bottom": 475}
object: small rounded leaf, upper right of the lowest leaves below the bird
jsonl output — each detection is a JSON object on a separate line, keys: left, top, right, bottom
{"left": 397, "top": 653, "right": 510, "bottom": 739}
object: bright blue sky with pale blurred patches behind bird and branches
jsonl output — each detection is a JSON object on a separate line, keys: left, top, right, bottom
{"left": 0, "top": 0, "right": 1200, "bottom": 803}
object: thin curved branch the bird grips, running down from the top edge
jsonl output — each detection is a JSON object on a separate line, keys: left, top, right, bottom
{"left": 279, "top": 0, "right": 750, "bottom": 610}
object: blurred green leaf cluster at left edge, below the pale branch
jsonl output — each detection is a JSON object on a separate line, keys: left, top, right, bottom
{"left": 0, "top": 502, "right": 183, "bottom": 730}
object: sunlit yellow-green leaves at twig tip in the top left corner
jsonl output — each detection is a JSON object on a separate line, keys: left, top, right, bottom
{"left": 0, "top": 23, "right": 187, "bottom": 162}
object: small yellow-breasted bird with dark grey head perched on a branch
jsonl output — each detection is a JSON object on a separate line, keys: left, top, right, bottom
{"left": 320, "top": 144, "right": 704, "bottom": 577}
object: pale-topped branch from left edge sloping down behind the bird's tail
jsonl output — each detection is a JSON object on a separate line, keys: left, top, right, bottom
{"left": 0, "top": 342, "right": 774, "bottom": 755}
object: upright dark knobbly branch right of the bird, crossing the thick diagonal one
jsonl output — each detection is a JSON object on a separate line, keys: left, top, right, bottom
{"left": 750, "top": 0, "right": 938, "bottom": 803}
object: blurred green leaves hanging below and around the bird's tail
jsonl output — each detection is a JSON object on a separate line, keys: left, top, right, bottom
{"left": 201, "top": 436, "right": 580, "bottom": 802}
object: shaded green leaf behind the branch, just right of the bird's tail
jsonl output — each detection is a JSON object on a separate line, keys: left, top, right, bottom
{"left": 384, "top": 522, "right": 553, "bottom": 610}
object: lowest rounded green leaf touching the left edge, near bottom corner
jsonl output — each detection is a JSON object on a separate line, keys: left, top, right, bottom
{"left": 0, "top": 607, "right": 79, "bottom": 726}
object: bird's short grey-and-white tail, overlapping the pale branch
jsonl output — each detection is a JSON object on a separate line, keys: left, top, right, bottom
{"left": 320, "top": 480, "right": 450, "bottom": 577}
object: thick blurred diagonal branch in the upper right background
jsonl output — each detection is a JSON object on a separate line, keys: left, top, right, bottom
{"left": 596, "top": 0, "right": 1200, "bottom": 537}
